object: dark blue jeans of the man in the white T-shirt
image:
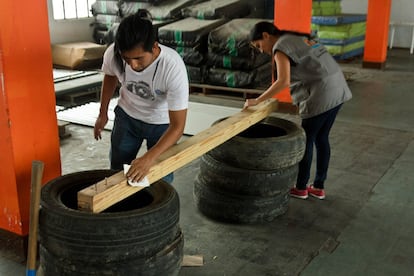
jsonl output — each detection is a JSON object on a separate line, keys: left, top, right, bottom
{"left": 109, "top": 106, "right": 174, "bottom": 183}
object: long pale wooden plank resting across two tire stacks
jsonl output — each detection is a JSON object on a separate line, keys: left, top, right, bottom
{"left": 78, "top": 99, "right": 278, "bottom": 213}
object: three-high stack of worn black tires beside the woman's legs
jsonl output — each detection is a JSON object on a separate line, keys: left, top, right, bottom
{"left": 194, "top": 117, "right": 305, "bottom": 223}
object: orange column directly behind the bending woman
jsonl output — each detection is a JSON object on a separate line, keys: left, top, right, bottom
{"left": 274, "top": 0, "right": 312, "bottom": 103}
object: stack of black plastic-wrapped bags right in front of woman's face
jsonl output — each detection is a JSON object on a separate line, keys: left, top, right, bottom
{"left": 206, "top": 18, "right": 272, "bottom": 87}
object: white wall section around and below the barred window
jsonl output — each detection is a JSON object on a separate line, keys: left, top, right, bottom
{"left": 47, "top": 0, "right": 93, "bottom": 43}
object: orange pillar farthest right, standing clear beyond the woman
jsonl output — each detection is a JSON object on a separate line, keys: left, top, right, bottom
{"left": 362, "top": 0, "right": 392, "bottom": 69}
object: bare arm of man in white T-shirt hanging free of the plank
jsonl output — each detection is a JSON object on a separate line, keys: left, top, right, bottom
{"left": 94, "top": 75, "right": 118, "bottom": 140}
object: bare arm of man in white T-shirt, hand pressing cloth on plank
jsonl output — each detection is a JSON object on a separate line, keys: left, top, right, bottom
{"left": 126, "top": 109, "right": 187, "bottom": 181}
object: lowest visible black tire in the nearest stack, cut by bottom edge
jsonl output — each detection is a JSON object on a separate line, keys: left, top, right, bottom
{"left": 39, "top": 233, "right": 184, "bottom": 276}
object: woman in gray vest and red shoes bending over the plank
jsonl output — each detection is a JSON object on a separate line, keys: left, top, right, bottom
{"left": 244, "top": 21, "right": 352, "bottom": 199}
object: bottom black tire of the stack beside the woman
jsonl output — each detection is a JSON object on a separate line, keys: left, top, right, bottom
{"left": 193, "top": 178, "right": 289, "bottom": 224}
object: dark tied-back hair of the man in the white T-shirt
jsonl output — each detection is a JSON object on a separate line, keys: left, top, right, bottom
{"left": 114, "top": 9, "right": 157, "bottom": 69}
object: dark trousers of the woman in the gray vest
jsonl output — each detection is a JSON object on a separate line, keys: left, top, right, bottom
{"left": 296, "top": 104, "right": 342, "bottom": 190}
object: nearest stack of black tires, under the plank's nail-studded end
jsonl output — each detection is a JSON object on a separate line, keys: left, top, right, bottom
{"left": 39, "top": 170, "right": 184, "bottom": 276}
